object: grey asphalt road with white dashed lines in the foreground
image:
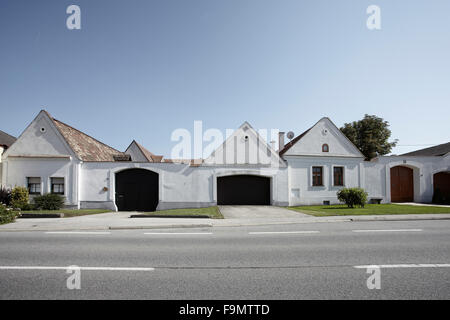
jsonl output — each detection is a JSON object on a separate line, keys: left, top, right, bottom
{"left": 0, "top": 220, "right": 450, "bottom": 299}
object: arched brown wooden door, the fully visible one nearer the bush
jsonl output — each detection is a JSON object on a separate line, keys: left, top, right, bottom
{"left": 391, "top": 166, "right": 414, "bottom": 202}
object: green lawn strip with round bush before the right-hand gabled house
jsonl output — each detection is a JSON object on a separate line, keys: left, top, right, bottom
{"left": 288, "top": 204, "right": 450, "bottom": 217}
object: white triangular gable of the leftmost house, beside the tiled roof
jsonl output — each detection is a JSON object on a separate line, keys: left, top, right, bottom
{"left": 4, "top": 111, "right": 74, "bottom": 157}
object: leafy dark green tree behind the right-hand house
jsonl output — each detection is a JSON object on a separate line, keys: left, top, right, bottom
{"left": 341, "top": 114, "right": 398, "bottom": 160}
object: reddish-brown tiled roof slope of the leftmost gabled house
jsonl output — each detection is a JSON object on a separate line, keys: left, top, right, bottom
{"left": 47, "top": 113, "right": 125, "bottom": 161}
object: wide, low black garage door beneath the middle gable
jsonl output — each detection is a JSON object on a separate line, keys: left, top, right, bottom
{"left": 217, "top": 175, "right": 270, "bottom": 205}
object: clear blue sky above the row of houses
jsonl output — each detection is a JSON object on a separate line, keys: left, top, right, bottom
{"left": 0, "top": 0, "right": 450, "bottom": 157}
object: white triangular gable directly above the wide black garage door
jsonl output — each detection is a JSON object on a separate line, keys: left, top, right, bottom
{"left": 204, "top": 122, "right": 285, "bottom": 167}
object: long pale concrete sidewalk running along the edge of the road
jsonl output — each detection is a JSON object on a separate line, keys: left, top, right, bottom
{"left": 0, "top": 212, "right": 450, "bottom": 232}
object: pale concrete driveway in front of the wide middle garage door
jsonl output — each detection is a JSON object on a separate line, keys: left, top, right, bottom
{"left": 219, "top": 206, "right": 311, "bottom": 219}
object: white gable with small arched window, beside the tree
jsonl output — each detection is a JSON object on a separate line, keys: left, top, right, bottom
{"left": 280, "top": 118, "right": 364, "bottom": 158}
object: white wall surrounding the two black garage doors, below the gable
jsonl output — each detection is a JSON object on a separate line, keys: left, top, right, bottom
{"left": 80, "top": 162, "right": 288, "bottom": 210}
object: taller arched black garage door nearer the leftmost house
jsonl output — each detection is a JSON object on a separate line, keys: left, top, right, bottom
{"left": 116, "top": 169, "right": 159, "bottom": 211}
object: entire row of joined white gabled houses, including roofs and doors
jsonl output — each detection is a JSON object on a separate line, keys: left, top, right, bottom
{"left": 1, "top": 110, "right": 450, "bottom": 211}
